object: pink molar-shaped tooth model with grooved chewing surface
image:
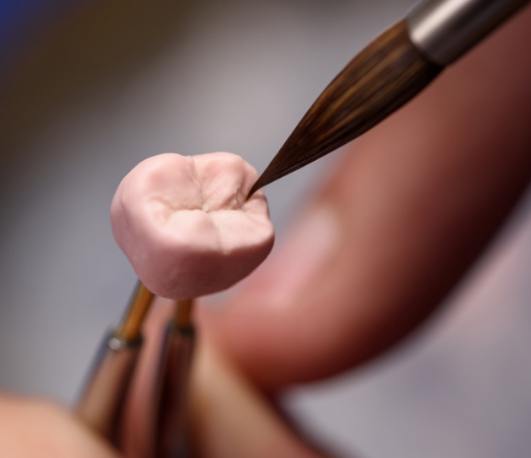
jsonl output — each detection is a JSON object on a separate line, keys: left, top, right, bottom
{"left": 111, "top": 153, "right": 274, "bottom": 299}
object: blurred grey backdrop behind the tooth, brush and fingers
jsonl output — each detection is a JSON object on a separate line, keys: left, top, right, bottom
{"left": 0, "top": 0, "right": 531, "bottom": 458}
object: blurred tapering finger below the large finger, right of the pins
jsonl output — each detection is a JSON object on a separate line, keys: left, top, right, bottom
{"left": 191, "top": 341, "right": 325, "bottom": 458}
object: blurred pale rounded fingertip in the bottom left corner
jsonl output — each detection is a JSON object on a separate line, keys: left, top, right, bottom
{"left": 0, "top": 395, "right": 117, "bottom": 458}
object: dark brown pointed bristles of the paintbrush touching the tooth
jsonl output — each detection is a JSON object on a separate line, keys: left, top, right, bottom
{"left": 249, "top": 21, "right": 441, "bottom": 195}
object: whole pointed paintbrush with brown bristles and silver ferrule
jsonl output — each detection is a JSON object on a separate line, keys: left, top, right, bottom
{"left": 249, "top": 0, "right": 528, "bottom": 196}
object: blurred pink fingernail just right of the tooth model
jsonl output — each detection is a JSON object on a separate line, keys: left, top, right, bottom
{"left": 249, "top": 205, "right": 340, "bottom": 306}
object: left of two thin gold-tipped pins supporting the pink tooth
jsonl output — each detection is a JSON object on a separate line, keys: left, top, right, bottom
{"left": 75, "top": 282, "right": 153, "bottom": 445}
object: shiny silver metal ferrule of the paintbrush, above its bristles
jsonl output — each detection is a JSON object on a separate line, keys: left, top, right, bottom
{"left": 406, "top": 0, "right": 528, "bottom": 67}
